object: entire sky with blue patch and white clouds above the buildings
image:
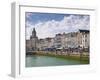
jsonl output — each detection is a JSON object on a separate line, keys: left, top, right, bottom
{"left": 25, "top": 12, "right": 90, "bottom": 39}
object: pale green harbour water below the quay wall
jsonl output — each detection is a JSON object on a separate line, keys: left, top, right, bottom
{"left": 26, "top": 55, "right": 81, "bottom": 67}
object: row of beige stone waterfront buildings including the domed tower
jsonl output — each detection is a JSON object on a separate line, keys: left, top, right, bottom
{"left": 26, "top": 28, "right": 90, "bottom": 51}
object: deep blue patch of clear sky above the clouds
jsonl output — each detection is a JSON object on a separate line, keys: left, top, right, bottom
{"left": 26, "top": 12, "right": 70, "bottom": 24}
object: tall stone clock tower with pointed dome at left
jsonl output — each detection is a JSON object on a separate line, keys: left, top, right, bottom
{"left": 30, "top": 28, "right": 38, "bottom": 51}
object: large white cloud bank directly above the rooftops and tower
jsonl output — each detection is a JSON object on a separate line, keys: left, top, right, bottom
{"left": 26, "top": 15, "right": 90, "bottom": 39}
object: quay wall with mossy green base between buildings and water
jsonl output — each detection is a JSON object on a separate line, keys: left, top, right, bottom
{"left": 27, "top": 51, "right": 89, "bottom": 63}
